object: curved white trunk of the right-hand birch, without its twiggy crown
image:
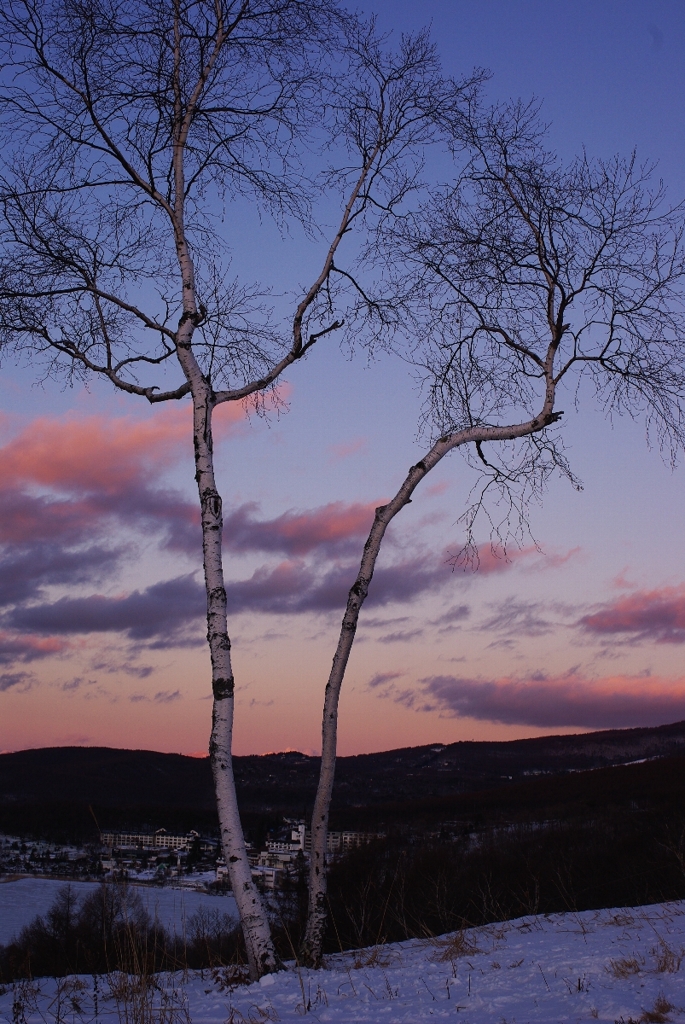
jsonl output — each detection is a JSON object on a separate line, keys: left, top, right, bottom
{"left": 302, "top": 395, "right": 560, "bottom": 967}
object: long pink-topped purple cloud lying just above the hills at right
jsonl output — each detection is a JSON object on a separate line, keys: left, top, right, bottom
{"left": 382, "top": 671, "right": 685, "bottom": 729}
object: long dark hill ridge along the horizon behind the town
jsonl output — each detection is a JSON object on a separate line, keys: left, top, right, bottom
{"left": 0, "top": 722, "right": 685, "bottom": 838}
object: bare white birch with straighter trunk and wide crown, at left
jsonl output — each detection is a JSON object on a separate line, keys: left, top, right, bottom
{"left": 0, "top": 0, "right": 479, "bottom": 978}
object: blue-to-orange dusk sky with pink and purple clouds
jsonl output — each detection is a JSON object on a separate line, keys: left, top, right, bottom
{"left": 0, "top": 0, "right": 685, "bottom": 755}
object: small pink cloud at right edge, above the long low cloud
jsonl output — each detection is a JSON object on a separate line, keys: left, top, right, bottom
{"left": 581, "top": 585, "right": 685, "bottom": 643}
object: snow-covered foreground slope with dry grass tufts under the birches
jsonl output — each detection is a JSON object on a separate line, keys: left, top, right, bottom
{"left": 0, "top": 901, "right": 685, "bottom": 1024}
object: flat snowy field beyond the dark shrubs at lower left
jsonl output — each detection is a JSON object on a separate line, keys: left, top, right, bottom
{"left": 0, "top": 879, "right": 238, "bottom": 945}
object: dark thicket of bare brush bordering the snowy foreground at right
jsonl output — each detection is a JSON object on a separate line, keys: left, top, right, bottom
{"left": 321, "top": 813, "right": 685, "bottom": 951}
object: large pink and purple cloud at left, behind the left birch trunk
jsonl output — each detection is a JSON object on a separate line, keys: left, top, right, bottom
{"left": 0, "top": 388, "right": 285, "bottom": 550}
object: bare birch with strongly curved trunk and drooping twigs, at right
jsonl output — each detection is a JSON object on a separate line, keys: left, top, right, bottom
{"left": 303, "top": 97, "right": 685, "bottom": 965}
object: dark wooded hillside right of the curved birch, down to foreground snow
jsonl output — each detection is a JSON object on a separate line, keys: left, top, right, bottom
{"left": 313, "top": 757, "right": 685, "bottom": 951}
